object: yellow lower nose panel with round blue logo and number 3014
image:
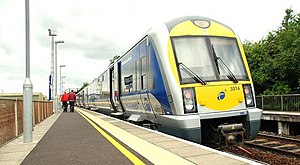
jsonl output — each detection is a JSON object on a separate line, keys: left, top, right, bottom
{"left": 195, "top": 85, "right": 244, "bottom": 113}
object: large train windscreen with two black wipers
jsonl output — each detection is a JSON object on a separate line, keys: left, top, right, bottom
{"left": 172, "top": 36, "right": 248, "bottom": 83}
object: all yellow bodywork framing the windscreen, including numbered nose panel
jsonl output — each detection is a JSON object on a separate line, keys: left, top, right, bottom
{"left": 168, "top": 18, "right": 252, "bottom": 113}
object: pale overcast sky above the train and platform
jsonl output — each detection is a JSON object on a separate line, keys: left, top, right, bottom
{"left": 0, "top": 0, "right": 300, "bottom": 95}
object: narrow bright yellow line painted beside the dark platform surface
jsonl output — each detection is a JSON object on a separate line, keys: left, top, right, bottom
{"left": 77, "top": 111, "right": 145, "bottom": 165}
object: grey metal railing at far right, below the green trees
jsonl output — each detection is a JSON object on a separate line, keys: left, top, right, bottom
{"left": 256, "top": 94, "right": 300, "bottom": 112}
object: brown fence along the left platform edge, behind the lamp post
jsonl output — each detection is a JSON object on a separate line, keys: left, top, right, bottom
{"left": 0, "top": 98, "right": 53, "bottom": 147}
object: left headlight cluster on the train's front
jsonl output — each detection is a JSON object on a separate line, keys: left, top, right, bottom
{"left": 182, "top": 88, "right": 197, "bottom": 113}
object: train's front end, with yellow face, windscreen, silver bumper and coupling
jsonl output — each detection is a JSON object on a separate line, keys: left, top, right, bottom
{"left": 160, "top": 17, "right": 262, "bottom": 145}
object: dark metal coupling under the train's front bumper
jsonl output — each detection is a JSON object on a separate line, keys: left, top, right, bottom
{"left": 218, "top": 123, "right": 245, "bottom": 146}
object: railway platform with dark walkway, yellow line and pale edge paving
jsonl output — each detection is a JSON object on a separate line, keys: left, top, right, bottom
{"left": 0, "top": 108, "right": 259, "bottom": 165}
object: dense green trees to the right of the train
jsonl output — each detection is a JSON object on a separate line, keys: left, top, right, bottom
{"left": 244, "top": 9, "right": 300, "bottom": 94}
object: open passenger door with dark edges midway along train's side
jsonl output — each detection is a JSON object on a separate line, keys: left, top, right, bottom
{"left": 109, "top": 63, "right": 123, "bottom": 112}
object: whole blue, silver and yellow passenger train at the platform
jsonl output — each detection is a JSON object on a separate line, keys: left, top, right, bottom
{"left": 77, "top": 16, "right": 262, "bottom": 145}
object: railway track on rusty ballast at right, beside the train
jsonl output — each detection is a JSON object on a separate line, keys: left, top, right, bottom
{"left": 245, "top": 133, "right": 300, "bottom": 159}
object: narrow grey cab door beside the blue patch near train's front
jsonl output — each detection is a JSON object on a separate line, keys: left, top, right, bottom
{"left": 139, "top": 38, "right": 156, "bottom": 121}
